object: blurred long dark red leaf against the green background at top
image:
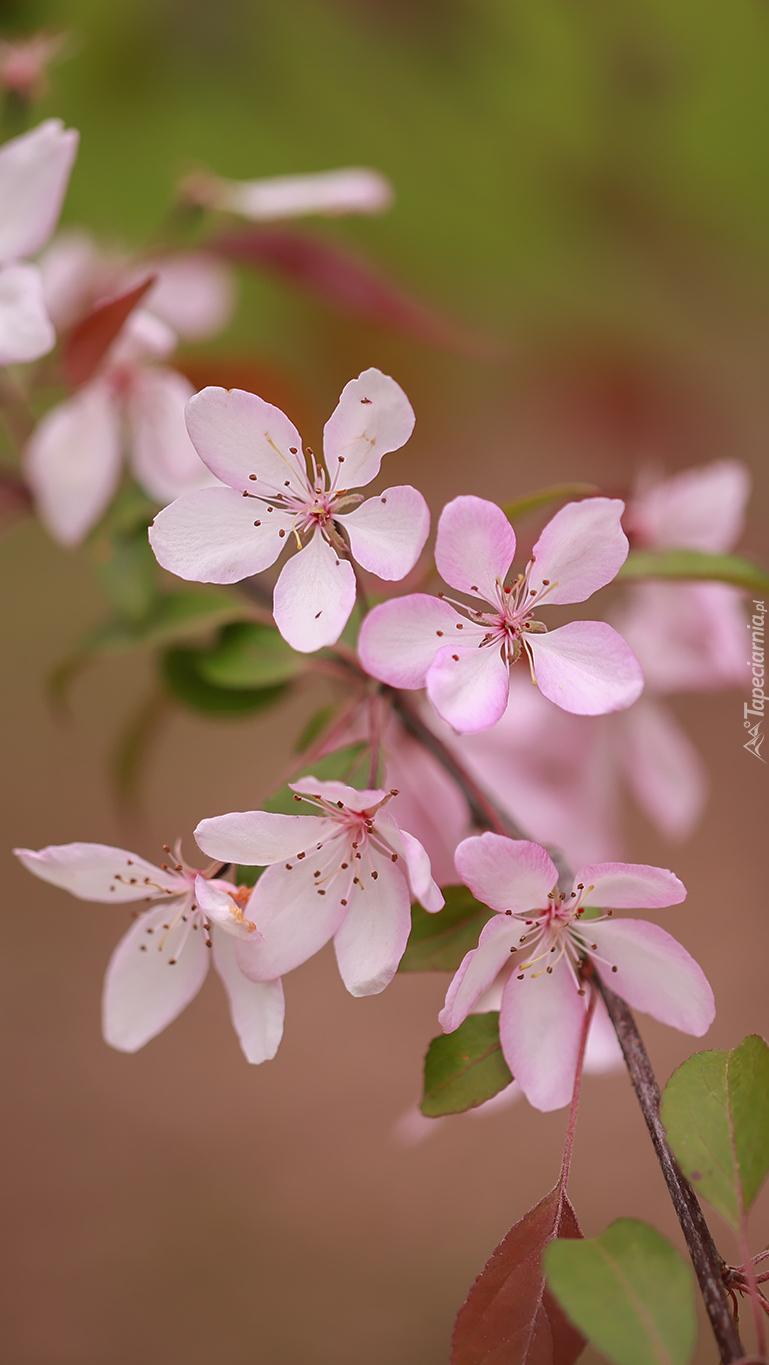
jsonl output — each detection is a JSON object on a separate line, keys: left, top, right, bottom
{"left": 208, "top": 228, "right": 486, "bottom": 354}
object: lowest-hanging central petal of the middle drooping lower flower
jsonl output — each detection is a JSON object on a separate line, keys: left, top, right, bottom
{"left": 333, "top": 845, "right": 411, "bottom": 996}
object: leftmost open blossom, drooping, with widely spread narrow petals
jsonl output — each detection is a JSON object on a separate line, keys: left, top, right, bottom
{"left": 14, "top": 844, "right": 284, "bottom": 1062}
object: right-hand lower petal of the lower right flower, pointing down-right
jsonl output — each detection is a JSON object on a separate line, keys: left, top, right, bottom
{"left": 583, "top": 920, "right": 716, "bottom": 1037}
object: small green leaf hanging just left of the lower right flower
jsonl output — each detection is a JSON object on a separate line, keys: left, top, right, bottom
{"left": 419, "top": 1015, "right": 512, "bottom": 1118}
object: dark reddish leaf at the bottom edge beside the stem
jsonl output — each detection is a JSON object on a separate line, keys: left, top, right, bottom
{"left": 451, "top": 1181, "right": 585, "bottom": 1365}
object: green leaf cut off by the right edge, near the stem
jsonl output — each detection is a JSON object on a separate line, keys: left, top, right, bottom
{"left": 660, "top": 1033, "right": 769, "bottom": 1229}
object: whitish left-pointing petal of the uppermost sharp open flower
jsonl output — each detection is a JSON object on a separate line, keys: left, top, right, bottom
{"left": 149, "top": 489, "right": 291, "bottom": 583}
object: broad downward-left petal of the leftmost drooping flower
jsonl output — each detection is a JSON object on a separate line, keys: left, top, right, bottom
{"left": 101, "top": 905, "right": 209, "bottom": 1052}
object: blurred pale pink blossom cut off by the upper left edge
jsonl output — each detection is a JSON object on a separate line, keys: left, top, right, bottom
{"left": 0, "top": 119, "right": 78, "bottom": 364}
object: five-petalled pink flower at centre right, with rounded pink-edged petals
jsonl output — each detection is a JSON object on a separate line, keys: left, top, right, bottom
{"left": 358, "top": 497, "right": 643, "bottom": 734}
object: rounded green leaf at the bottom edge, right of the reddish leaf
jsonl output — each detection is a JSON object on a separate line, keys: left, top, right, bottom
{"left": 545, "top": 1218, "right": 697, "bottom": 1365}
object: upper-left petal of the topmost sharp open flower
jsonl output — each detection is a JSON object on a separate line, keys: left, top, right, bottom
{"left": 187, "top": 386, "right": 307, "bottom": 497}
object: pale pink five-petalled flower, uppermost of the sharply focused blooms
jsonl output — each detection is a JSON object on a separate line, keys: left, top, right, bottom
{"left": 150, "top": 370, "right": 430, "bottom": 654}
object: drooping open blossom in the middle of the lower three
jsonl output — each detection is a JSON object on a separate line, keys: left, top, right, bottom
{"left": 195, "top": 777, "right": 444, "bottom": 995}
